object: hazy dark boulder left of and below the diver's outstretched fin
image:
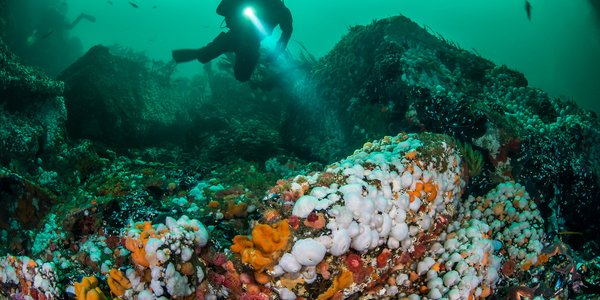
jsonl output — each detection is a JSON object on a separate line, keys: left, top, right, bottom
{"left": 59, "top": 45, "right": 191, "bottom": 147}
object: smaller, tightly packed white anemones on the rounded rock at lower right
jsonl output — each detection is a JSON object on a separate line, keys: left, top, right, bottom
{"left": 410, "top": 182, "right": 544, "bottom": 300}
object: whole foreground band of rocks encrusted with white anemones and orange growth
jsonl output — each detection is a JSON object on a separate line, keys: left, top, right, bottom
{"left": 0, "top": 133, "right": 590, "bottom": 299}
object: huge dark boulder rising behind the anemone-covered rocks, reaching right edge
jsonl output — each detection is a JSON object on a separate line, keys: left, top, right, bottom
{"left": 283, "top": 16, "right": 600, "bottom": 247}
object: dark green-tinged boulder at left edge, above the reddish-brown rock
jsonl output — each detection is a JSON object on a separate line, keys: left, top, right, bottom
{"left": 0, "top": 40, "right": 67, "bottom": 171}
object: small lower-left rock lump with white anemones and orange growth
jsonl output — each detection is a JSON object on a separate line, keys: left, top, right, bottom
{"left": 119, "top": 216, "right": 208, "bottom": 298}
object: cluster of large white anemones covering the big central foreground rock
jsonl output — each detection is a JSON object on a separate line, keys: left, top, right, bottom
{"left": 270, "top": 135, "right": 464, "bottom": 293}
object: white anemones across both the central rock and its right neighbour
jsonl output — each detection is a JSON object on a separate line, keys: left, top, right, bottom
{"left": 255, "top": 135, "right": 543, "bottom": 299}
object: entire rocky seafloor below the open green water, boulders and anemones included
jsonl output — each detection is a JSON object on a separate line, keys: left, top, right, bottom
{"left": 0, "top": 12, "right": 600, "bottom": 300}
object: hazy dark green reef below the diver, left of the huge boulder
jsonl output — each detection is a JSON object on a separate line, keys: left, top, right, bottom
{"left": 58, "top": 45, "right": 283, "bottom": 161}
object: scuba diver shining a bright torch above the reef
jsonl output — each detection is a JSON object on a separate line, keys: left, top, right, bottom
{"left": 173, "top": 0, "right": 293, "bottom": 82}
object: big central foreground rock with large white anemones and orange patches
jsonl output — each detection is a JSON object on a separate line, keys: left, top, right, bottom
{"left": 223, "top": 135, "right": 491, "bottom": 299}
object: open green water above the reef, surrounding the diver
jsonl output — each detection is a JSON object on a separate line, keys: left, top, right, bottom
{"left": 4, "top": 0, "right": 600, "bottom": 113}
